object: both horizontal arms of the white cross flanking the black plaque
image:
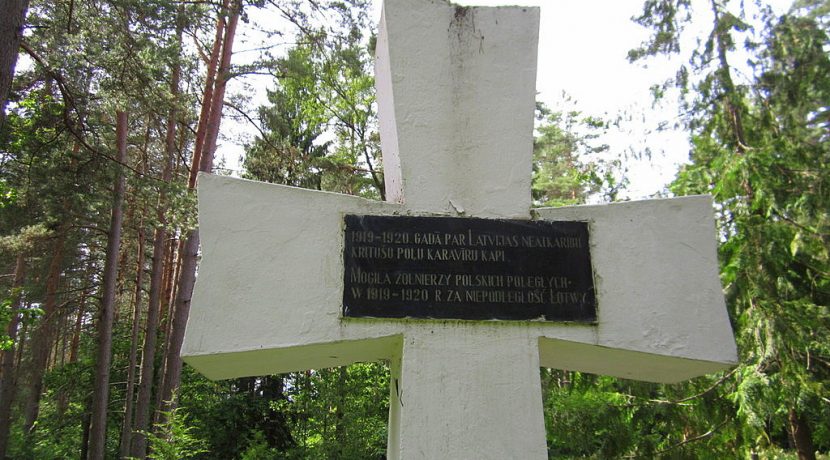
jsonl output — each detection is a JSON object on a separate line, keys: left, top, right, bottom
{"left": 182, "top": 175, "right": 736, "bottom": 381}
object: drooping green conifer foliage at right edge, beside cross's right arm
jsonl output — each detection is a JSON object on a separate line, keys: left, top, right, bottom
{"left": 673, "top": 8, "right": 830, "bottom": 449}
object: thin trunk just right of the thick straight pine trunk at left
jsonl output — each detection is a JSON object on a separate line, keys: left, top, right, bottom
{"left": 119, "top": 226, "right": 144, "bottom": 458}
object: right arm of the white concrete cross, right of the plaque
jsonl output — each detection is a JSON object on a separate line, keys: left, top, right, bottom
{"left": 537, "top": 196, "right": 737, "bottom": 382}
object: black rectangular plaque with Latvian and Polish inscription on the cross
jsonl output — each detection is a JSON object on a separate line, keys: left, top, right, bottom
{"left": 343, "top": 215, "right": 596, "bottom": 322}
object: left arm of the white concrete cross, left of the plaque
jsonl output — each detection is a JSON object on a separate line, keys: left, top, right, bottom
{"left": 182, "top": 174, "right": 401, "bottom": 379}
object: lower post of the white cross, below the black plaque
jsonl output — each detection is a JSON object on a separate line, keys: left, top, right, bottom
{"left": 388, "top": 324, "right": 547, "bottom": 459}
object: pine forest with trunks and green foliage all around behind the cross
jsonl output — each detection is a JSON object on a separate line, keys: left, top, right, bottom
{"left": 0, "top": 0, "right": 830, "bottom": 460}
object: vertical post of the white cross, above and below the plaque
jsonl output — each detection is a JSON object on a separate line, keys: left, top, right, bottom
{"left": 375, "top": 0, "right": 547, "bottom": 458}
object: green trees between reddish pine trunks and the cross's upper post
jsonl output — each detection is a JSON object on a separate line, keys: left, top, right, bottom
{"left": 243, "top": 10, "right": 384, "bottom": 198}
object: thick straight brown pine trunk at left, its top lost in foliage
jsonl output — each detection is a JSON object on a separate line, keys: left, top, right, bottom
{"left": 88, "top": 112, "right": 127, "bottom": 460}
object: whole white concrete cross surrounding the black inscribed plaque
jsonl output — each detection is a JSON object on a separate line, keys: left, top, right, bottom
{"left": 182, "top": 0, "right": 737, "bottom": 459}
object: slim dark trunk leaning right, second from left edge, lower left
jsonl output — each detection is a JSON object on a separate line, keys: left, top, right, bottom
{"left": 23, "top": 234, "right": 66, "bottom": 435}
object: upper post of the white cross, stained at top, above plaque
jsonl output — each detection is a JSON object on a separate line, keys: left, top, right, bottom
{"left": 375, "top": 0, "right": 539, "bottom": 218}
